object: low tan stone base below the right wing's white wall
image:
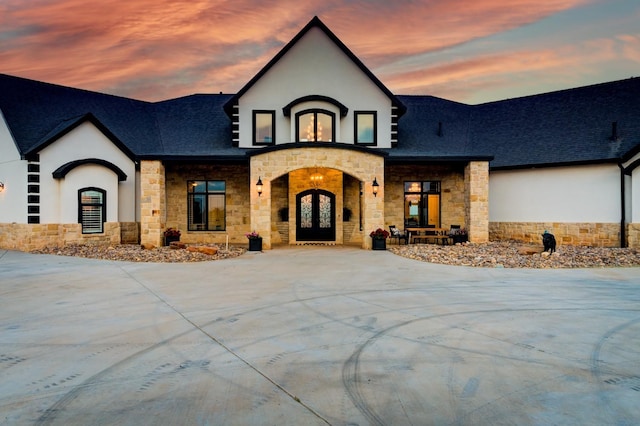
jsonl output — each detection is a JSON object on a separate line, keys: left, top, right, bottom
{"left": 489, "top": 222, "right": 620, "bottom": 247}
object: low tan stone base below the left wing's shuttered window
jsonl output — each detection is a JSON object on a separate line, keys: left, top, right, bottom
{"left": 0, "top": 222, "right": 121, "bottom": 251}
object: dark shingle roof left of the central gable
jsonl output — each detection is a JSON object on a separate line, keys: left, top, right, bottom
{"left": 0, "top": 74, "right": 244, "bottom": 158}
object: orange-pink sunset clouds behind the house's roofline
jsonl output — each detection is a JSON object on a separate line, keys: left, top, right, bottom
{"left": 0, "top": 0, "right": 624, "bottom": 100}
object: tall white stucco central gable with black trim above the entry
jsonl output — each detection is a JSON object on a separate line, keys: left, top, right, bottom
{"left": 225, "top": 18, "right": 404, "bottom": 148}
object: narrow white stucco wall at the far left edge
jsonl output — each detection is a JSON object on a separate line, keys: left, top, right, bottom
{"left": 0, "top": 110, "right": 27, "bottom": 223}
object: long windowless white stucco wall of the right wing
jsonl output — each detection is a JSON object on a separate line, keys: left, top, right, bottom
{"left": 489, "top": 164, "right": 621, "bottom": 223}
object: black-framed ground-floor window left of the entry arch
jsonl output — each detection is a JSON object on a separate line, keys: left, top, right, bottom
{"left": 187, "top": 180, "right": 227, "bottom": 231}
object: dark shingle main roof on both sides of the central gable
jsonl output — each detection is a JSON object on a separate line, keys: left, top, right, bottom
{"left": 0, "top": 74, "right": 640, "bottom": 170}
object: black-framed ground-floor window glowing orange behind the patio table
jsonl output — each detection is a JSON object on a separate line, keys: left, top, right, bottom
{"left": 404, "top": 181, "right": 440, "bottom": 228}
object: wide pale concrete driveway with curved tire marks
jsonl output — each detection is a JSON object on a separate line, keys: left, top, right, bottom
{"left": 0, "top": 247, "right": 640, "bottom": 425}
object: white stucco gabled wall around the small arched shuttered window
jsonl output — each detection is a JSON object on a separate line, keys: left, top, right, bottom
{"left": 40, "top": 122, "right": 136, "bottom": 223}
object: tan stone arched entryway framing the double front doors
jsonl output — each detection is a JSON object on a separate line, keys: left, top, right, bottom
{"left": 250, "top": 143, "right": 386, "bottom": 249}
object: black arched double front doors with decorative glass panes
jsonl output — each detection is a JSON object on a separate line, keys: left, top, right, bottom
{"left": 296, "top": 189, "right": 336, "bottom": 241}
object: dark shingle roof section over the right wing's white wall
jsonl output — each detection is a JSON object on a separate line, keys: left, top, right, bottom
{"left": 469, "top": 78, "right": 640, "bottom": 168}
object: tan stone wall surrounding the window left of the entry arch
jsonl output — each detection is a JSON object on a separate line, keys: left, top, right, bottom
{"left": 162, "top": 164, "right": 251, "bottom": 244}
